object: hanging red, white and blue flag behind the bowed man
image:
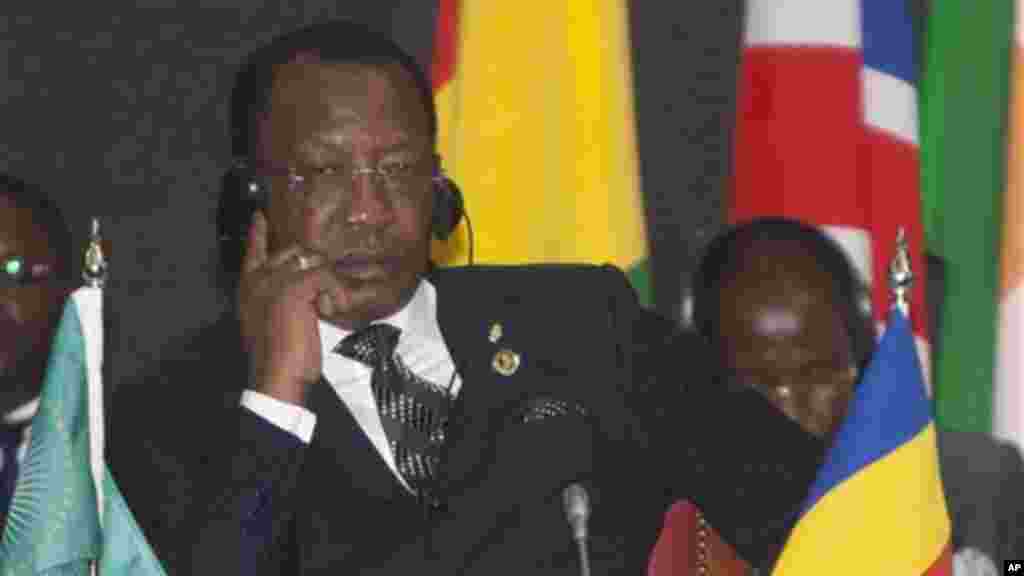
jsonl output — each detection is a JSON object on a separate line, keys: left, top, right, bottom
{"left": 729, "top": 0, "right": 929, "bottom": 381}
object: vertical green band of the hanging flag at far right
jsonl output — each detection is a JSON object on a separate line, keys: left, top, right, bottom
{"left": 921, "top": 0, "right": 1019, "bottom": 433}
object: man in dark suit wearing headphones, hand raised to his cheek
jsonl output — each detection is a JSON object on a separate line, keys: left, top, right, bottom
{"left": 111, "top": 23, "right": 823, "bottom": 575}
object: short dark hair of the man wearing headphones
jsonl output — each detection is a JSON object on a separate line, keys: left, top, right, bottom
{"left": 230, "top": 20, "right": 437, "bottom": 158}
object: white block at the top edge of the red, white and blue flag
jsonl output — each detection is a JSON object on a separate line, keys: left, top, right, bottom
{"left": 745, "top": 0, "right": 861, "bottom": 48}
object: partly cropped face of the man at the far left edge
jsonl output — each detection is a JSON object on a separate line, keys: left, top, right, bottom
{"left": 0, "top": 191, "right": 67, "bottom": 412}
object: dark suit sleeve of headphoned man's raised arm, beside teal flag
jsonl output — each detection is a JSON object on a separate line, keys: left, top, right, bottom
{"left": 109, "top": 317, "right": 305, "bottom": 575}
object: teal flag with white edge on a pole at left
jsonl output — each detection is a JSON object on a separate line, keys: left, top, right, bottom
{"left": 0, "top": 287, "right": 164, "bottom": 576}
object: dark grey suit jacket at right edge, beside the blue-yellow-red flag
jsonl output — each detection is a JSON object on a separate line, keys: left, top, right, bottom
{"left": 937, "top": 429, "right": 1024, "bottom": 567}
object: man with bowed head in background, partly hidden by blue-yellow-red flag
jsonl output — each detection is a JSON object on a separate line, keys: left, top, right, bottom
{"left": 693, "top": 218, "right": 1024, "bottom": 574}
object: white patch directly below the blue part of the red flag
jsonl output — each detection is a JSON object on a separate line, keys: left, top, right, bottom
{"left": 860, "top": 67, "right": 918, "bottom": 146}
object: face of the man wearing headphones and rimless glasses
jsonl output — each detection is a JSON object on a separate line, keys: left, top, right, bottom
{"left": 257, "top": 63, "right": 434, "bottom": 328}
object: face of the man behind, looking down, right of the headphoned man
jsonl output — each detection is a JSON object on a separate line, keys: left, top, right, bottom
{"left": 719, "top": 241, "right": 857, "bottom": 437}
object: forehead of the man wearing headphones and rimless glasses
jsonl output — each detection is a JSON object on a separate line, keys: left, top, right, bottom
{"left": 260, "top": 59, "right": 430, "bottom": 158}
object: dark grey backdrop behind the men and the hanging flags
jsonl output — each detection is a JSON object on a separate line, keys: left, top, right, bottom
{"left": 0, "top": 0, "right": 924, "bottom": 416}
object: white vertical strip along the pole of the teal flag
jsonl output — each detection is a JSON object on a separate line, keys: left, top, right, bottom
{"left": 72, "top": 287, "right": 104, "bottom": 527}
